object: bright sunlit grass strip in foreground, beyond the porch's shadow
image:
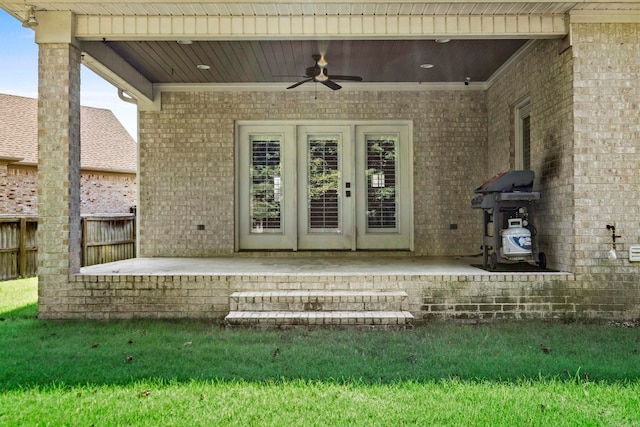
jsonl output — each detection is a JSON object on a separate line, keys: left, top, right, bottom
{"left": 0, "top": 380, "right": 640, "bottom": 426}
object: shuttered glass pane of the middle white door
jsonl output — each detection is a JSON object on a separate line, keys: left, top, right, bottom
{"left": 307, "top": 136, "right": 340, "bottom": 231}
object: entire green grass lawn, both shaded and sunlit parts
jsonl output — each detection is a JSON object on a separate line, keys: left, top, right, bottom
{"left": 0, "top": 279, "right": 640, "bottom": 426}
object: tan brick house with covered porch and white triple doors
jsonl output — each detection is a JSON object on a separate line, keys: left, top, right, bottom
{"left": 0, "top": 0, "right": 640, "bottom": 319}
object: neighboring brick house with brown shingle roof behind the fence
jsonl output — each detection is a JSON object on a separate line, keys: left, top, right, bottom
{"left": 0, "top": 94, "right": 137, "bottom": 215}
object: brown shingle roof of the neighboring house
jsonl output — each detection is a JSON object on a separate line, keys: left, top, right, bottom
{"left": 0, "top": 94, "right": 137, "bottom": 173}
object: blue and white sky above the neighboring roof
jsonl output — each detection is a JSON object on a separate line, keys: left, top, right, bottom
{"left": 0, "top": 9, "right": 138, "bottom": 140}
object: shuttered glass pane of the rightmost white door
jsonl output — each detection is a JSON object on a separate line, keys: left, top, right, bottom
{"left": 365, "top": 135, "right": 398, "bottom": 230}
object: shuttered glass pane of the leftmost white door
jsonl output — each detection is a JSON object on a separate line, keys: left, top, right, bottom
{"left": 249, "top": 136, "right": 283, "bottom": 233}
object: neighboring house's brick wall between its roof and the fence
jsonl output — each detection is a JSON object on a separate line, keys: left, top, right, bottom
{"left": 0, "top": 165, "right": 136, "bottom": 215}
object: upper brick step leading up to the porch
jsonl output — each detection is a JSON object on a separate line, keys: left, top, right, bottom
{"left": 230, "top": 290, "right": 408, "bottom": 312}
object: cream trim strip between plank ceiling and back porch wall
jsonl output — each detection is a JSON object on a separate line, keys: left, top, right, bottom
{"left": 154, "top": 82, "right": 487, "bottom": 93}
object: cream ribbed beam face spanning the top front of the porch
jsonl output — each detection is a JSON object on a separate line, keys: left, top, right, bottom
{"left": 76, "top": 14, "right": 568, "bottom": 40}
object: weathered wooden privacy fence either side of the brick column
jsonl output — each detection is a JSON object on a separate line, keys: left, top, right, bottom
{"left": 0, "top": 214, "right": 136, "bottom": 280}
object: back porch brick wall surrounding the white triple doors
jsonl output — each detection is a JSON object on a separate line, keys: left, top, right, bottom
{"left": 139, "top": 90, "right": 487, "bottom": 256}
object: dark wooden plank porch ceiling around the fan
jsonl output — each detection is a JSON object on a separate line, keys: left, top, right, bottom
{"left": 93, "top": 39, "right": 526, "bottom": 83}
